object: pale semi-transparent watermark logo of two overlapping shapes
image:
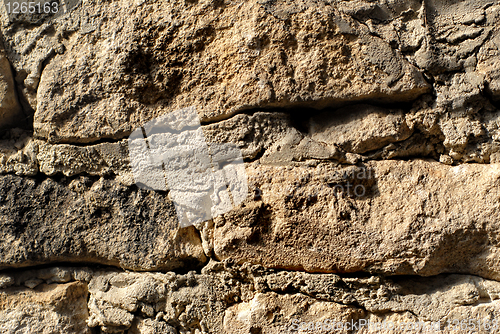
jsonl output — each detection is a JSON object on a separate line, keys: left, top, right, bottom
{"left": 128, "top": 107, "right": 248, "bottom": 227}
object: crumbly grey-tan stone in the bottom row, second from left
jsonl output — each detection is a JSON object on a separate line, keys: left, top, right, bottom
{"left": 88, "top": 272, "right": 244, "bottom": 333}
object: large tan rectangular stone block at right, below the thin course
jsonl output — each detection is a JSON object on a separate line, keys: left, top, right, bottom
{"left": 214, "top": 160, "right": 500, "bottom": 279}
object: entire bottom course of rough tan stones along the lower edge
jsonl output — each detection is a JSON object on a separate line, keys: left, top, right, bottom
{"left": 0, "top": 262, "right": 500, "bottom": 334}
